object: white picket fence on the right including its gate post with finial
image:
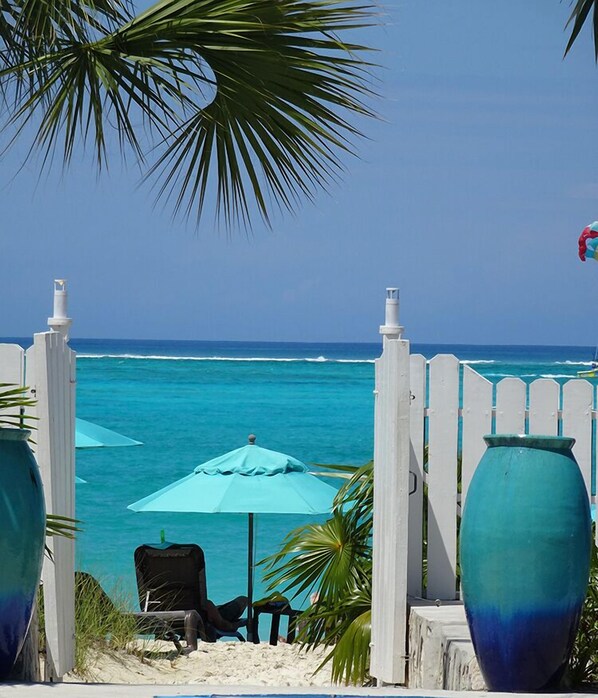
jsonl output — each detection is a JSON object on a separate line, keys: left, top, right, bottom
{"left": 370, "top": 289, "right": 598, "bottom": 684}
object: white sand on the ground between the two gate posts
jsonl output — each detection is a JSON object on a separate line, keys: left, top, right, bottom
{"left": 64, "top": 642, "right": 331, "bottom": 686}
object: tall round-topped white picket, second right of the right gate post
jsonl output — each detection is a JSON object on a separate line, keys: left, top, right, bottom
{"left": 426, "top": 354, "right": 459, "bottom": 599}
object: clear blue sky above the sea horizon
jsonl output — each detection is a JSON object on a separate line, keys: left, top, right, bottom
{"left": 0, "top": 0, "right": 598, "bottom": 345}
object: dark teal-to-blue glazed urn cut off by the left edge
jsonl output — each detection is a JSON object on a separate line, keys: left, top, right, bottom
{"left": 0, "top": 428, "right": 46, "bottom": 680}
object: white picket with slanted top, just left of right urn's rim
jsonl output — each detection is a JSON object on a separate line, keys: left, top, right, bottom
{"left": 461, "top": 365, "right": 492, "bottom": 507}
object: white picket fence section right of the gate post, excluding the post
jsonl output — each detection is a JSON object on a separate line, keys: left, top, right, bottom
{"left": 407, "top": 354, "right": 596, "bottom": 600}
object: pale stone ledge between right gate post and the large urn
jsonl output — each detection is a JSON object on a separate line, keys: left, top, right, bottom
{"left": 407, "top": 599, "right": 486, "bottom": 691}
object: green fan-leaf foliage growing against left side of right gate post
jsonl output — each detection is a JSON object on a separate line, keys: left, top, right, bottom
{"left": 262, "top": 462, "right": 374, "bottom": 684}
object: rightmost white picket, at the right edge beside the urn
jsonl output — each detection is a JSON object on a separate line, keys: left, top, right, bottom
{"left": 562, "top": 379, "right": 594, "bottom": 499}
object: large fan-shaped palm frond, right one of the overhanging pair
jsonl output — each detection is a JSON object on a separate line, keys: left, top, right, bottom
{"left": 144, "top": 0, "right": 380, "bottom": 224}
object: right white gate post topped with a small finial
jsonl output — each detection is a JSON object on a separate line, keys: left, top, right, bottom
{"left": 370, "top": 288, "right": 410, "bottom": 685}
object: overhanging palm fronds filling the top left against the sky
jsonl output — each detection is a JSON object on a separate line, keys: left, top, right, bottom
{"left": 0, "top": 0, "right": 373, "bottom": 224}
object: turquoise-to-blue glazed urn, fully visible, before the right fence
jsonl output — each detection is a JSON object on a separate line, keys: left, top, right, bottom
{"left": 460, "top": 434, "right": 591, "bottom": 692}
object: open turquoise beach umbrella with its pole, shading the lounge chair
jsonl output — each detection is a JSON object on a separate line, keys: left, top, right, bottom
{"left": 128, "top": 435, "right": 337, "bottom": 640}
